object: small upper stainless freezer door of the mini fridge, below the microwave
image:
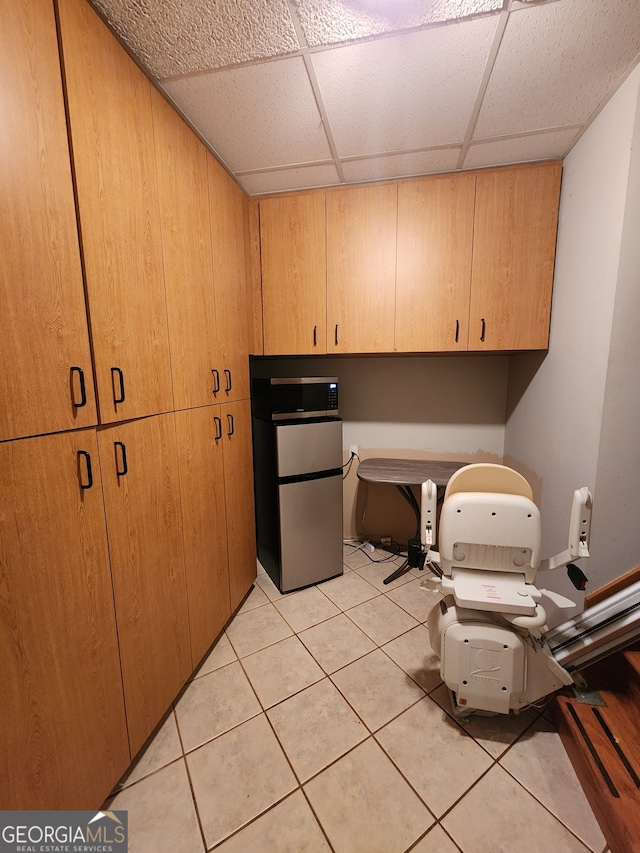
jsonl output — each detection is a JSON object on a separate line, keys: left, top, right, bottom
{"left": 274, "top": 418, "right": 342, "bottom": 477}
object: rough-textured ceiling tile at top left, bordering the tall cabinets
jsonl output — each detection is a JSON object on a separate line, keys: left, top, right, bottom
{"left": 91, "top": 0, "right": 300, "bottom": 79}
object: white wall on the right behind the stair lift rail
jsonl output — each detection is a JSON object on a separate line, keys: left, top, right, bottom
{"left": 505, "top": 69, "right": 640, "bottom": 594}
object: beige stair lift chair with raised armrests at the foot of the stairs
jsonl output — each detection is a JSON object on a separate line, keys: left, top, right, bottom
{"left": 420, "top": 463, "right": 591, "bottom": 716}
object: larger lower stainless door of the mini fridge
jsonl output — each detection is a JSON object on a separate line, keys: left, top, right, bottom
{"left": 278, "top": 474, "right": 342, "bottom": 592}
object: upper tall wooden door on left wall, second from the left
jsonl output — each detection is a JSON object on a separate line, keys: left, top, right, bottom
{"left": 58, "top": 0, "right": 173, "bottom": 423}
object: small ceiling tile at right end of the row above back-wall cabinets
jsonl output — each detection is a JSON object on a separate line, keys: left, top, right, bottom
{"left": 463, "top": 127, "right": 582, "bottom": 169}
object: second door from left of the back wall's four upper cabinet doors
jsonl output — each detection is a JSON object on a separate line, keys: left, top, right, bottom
{"left": 327, "top": 183, "right": 398, "bottom": 353}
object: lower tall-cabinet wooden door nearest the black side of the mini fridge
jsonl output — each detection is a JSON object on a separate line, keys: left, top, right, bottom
{"left": 221, "top": 400, "right": 257, "bottom": 611}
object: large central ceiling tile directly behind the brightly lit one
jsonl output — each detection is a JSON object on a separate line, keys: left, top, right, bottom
{"left": 311, "top": 16, "right": 498, "bottom": 157}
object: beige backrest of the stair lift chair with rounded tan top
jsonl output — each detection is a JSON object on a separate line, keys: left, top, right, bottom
{"left": 438, "top": 463, "right": 542, "bottom": 583}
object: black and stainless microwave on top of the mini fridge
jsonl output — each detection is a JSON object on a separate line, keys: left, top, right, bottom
{"left": 252, "top": 376, "right": 338, "bottom": 421}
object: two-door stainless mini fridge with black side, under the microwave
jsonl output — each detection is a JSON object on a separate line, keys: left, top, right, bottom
{"left": 253, "top": 417, "right": 342, "bottom": 592}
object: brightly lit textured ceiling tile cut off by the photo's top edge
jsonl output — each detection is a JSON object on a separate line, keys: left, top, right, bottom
{"left": 295, "top": 0, "right": 503, "bottom": 47}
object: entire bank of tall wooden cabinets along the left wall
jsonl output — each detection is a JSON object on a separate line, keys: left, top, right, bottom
{"left": 0, "top": 0, "right": 256, "bottom": 809}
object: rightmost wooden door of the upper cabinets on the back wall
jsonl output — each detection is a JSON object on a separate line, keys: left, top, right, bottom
{"left": 469, "top": 162, "right": 562, "bottom": 350}
